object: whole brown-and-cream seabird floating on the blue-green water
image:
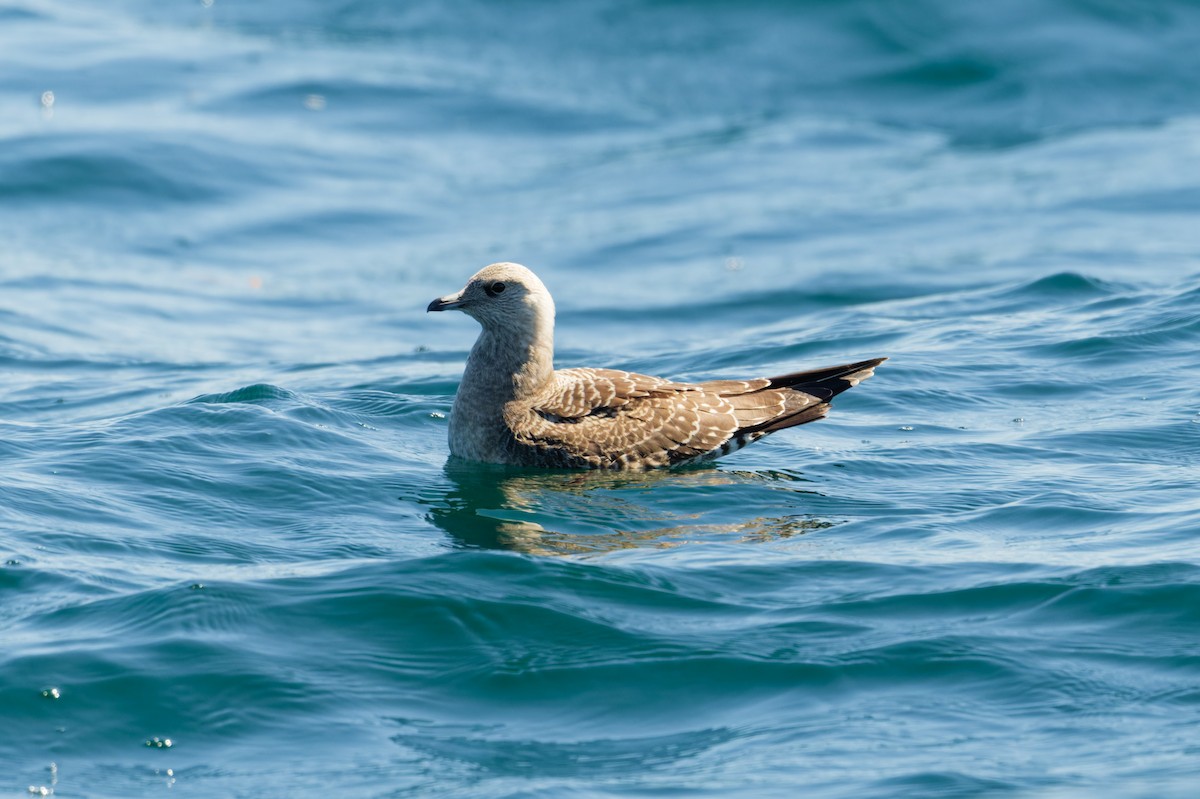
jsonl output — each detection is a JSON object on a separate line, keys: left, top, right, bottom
{"left": 427, "top": 264, "right": 887, "bottom": 469}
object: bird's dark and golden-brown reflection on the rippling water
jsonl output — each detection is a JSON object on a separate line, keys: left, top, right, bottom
{"left": 424, "top": 458, "right": 835, "bottom": 555}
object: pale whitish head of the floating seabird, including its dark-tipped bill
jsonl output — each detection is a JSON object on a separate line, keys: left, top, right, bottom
{"left": 426, "top": 263, "right": 554, "bottom": 332}
